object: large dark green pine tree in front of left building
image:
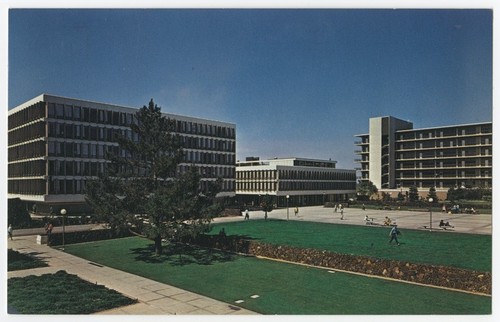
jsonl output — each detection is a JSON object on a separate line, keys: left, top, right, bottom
{"left": 86, "top": 99, "right": 222, "bottom": 254}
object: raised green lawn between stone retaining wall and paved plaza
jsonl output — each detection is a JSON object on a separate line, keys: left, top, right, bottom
{"left": 208, "top": 220, "right": 492, "bottom": 272}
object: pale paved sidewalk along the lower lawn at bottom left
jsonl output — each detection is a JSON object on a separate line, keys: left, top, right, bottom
{"left": 8, "top": 235, "right": 257, "bottom": 315}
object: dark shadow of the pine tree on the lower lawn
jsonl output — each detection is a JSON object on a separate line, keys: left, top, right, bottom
{"left": 131, "top": 244, "right": 236, "bottom": 266}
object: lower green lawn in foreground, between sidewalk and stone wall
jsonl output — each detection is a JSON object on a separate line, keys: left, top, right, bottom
{"left": 66, "top": 236, "right": 491, "bottom": 314}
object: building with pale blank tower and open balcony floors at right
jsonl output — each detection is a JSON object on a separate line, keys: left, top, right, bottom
{"left": 356, "top": 116, "right": 493, "bottom": 199}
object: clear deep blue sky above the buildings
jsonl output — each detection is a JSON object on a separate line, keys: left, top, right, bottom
{"left": 8, "top": 9, "right": 493, "bottom": 168}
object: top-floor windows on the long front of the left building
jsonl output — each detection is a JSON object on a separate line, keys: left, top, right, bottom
{"left": 48, "top": 103, "right": 236, "bottom": 139}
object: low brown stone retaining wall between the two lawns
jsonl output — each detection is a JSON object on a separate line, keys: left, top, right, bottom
{"left": 192, "top": 236, "right": 492, "bottom": 294}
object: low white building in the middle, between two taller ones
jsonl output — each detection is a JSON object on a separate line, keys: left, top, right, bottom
{"left": 236, "top": 157, "right": 356, "bottom": 206}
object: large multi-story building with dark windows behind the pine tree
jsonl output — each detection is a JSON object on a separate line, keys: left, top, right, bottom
{"left": 8, "top": 94, "right": 236, "bottom": 212}
